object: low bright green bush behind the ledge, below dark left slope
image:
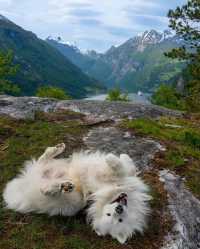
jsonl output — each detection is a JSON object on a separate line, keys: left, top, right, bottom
{"left": 36, "top": 86, "right": 71, "bottom": 100}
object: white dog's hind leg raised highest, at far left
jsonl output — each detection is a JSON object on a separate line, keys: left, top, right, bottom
{"left": 38, "top": 143, "right": 65, "bottom": 163}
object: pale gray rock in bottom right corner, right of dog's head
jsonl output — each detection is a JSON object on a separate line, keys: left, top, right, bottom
{"left": 160, "top": 170, "right": 200, "bottom": 249}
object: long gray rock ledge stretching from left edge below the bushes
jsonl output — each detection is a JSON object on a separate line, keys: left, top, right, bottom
{"left": 0, "top": 95, "right": 182, "bottom": 121}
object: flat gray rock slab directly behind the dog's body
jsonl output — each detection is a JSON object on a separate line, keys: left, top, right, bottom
{"left": 84, "top": 126, "right": 160, "bottom": 171}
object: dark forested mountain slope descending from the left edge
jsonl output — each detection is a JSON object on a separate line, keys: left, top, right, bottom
{"left": 0, "top": 15, "right": 105, "bottom": 98}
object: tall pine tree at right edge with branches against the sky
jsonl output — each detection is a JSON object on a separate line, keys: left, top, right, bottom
{"left": 166, "top": 0, "right": 200, "bottom": 111}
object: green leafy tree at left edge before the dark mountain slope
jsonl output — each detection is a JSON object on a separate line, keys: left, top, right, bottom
{"left": 0, "top": 51, "right": 20, "bottom": 95}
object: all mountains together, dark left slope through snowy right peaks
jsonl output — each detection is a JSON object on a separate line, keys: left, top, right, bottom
{"left": 0, "top": 12, "right": 184, "bottom": 99}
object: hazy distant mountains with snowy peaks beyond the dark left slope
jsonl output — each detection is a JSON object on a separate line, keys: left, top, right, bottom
{"left": 46, "top": 30, "right": 184, "bottom": 92}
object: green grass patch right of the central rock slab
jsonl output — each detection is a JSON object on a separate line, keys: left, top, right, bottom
{"left": 123, "top": 117, "right": 200, "bottom": 198}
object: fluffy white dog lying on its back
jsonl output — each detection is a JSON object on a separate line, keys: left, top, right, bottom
{"left": 3, "top": 144, "right": 151, "bottom": 243}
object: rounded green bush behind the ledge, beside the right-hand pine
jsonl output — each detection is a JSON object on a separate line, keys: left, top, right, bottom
{"left": 151, "top": 85, "right": 185, "bottom": 110}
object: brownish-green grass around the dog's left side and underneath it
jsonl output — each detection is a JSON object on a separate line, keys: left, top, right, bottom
{"left": 0, "top": 112, "right": 172, "bottom": 249}
